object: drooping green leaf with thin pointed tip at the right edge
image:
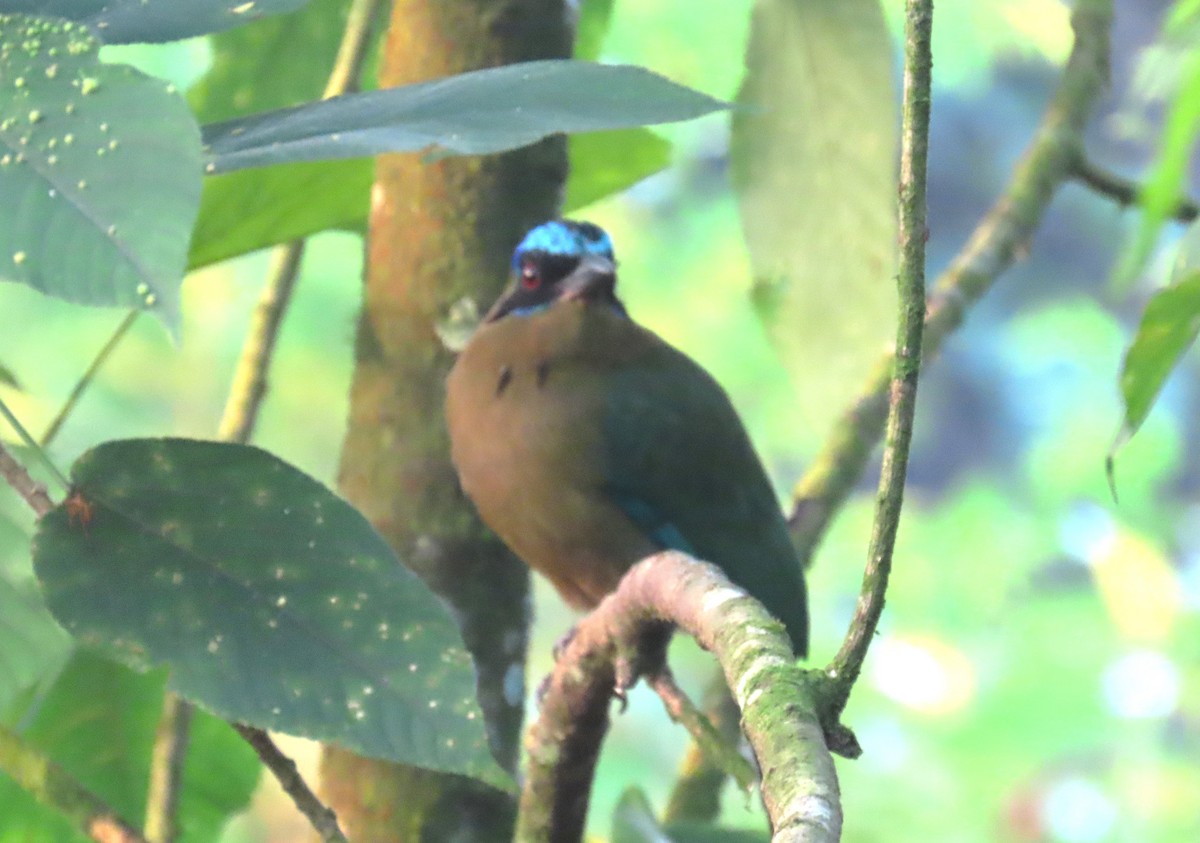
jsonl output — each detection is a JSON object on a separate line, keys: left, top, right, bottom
{"left": 1118, "top": 270, "right": 1200, "bottom": 443}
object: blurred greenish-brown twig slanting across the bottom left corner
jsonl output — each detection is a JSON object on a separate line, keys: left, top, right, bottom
{"left": 0, "top": 723, "right": 146, "bottom": 843}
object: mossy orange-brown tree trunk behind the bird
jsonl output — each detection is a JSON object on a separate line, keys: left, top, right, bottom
{"left": 322, "top": 0, "right": 571, "bottom": 843}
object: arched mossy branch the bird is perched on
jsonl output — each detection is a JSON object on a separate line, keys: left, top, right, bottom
{"left": 517, "top": 551, "right": 841, "bottom": 843}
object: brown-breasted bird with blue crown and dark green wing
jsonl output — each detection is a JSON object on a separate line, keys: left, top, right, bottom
{"left": 445, "top": 220, "right": 809, "bottom": 657}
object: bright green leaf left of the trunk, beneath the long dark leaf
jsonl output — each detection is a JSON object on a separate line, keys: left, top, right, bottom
{"left": 187, "top": 159, "right": 364, "bottom": 269}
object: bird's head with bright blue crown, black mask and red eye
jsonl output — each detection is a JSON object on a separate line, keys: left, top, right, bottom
{"left": 484, "top": 220, "right": 625, "bottom": 322}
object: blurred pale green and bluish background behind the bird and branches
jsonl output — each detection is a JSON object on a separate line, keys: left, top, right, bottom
{"left": 0, "top": 0, "right": 1200, "bottom": 843}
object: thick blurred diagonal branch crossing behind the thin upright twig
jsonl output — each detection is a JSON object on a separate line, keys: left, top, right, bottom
{"left": 790, "top": 0, "right": 1112, "bottom": 574}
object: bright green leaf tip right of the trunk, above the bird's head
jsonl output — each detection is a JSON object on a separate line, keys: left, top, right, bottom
{"left": 563, "top": 128, "right": 671, "bottom": 211}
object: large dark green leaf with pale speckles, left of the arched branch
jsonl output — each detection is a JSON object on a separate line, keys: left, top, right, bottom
{"left": 34, "top": 440, "right": 508, "bottom": 787}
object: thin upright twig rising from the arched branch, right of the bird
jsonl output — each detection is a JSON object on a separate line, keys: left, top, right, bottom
{"left": 828, "top": 0, "right": 934, "bottom": 712}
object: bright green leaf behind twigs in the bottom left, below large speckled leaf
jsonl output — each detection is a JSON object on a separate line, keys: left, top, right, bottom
{"left": 0, "top": 651, "right": 260, "bottom": 843}
